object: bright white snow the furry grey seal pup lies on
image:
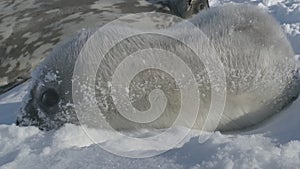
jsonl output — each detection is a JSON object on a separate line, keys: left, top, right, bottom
{"left": 0, "top": 0, "right": 300, "bottom": 169}
